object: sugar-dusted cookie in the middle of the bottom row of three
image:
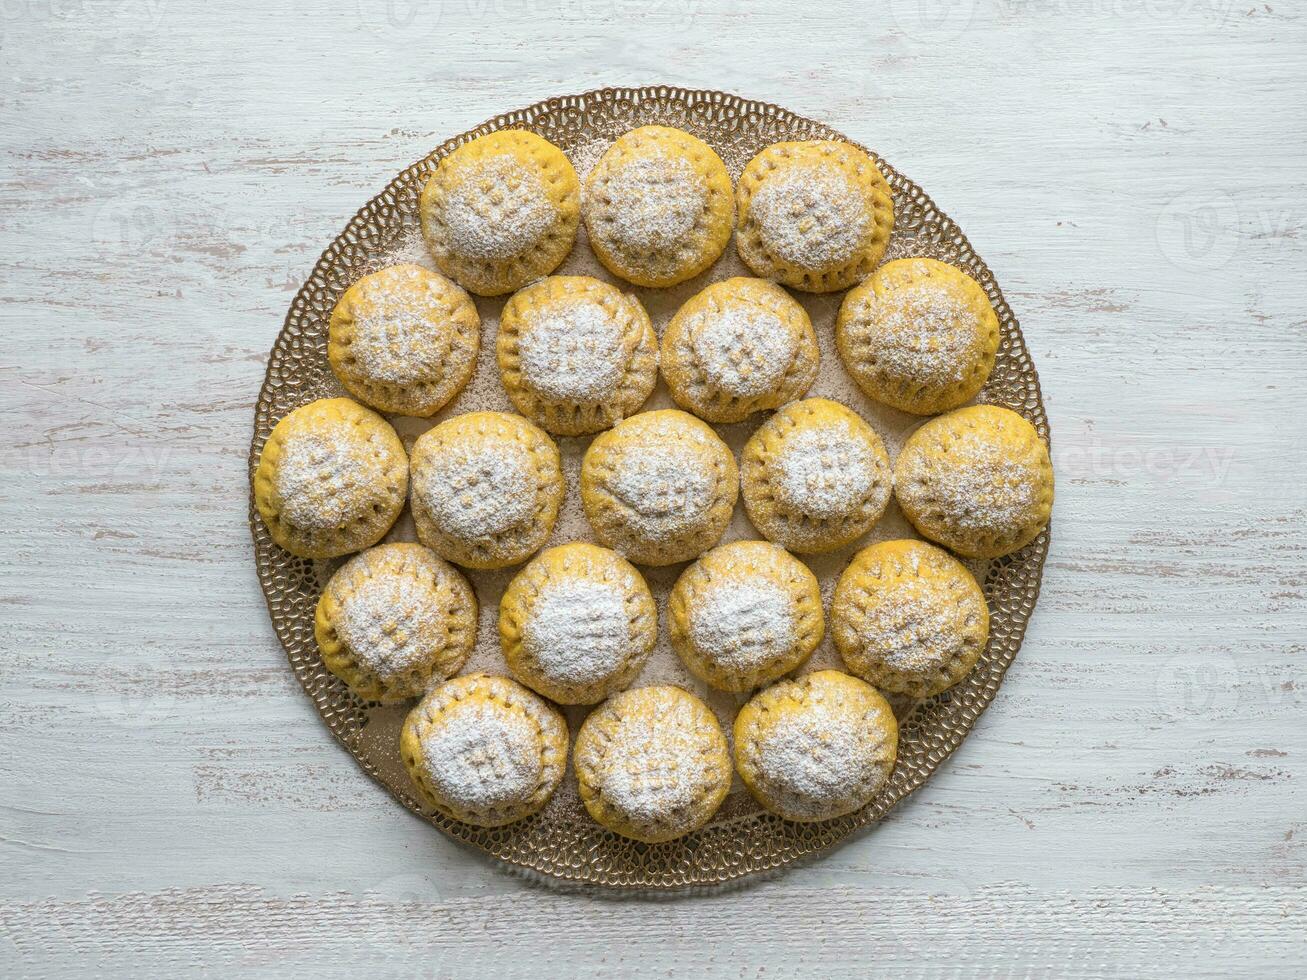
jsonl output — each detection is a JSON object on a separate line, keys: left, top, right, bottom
{"left": 574, "top": 686, "right": 731, "bottom": 844}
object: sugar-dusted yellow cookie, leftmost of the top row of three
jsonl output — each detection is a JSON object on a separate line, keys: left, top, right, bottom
{"left": 418, "top": 129, "right": 580, "bottom": 297}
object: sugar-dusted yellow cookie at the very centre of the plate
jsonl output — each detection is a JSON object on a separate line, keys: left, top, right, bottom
{"left": 580, "top": 409, "right": 740, "bottom": 564}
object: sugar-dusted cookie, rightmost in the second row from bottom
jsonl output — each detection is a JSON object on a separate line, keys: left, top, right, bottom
{"left": 830, "top": 541, "right": 989, "bottom": 698}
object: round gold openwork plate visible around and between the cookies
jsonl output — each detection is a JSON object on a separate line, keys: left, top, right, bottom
{"left": 250, "top": 88, "right": 1048, "bottom": 891}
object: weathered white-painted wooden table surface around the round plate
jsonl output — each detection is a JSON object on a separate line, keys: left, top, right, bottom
{"left": 0, "top": 0, "right": 1307, "bottom": 977}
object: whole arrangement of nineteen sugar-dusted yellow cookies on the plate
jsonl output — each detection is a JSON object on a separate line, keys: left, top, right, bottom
{"left": 254, "top": 125, "right": 1052, "bottom": 844}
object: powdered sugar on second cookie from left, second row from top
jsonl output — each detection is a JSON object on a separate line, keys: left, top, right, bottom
{"left": 519, "top": 299, "right": 625, "bottom": 404}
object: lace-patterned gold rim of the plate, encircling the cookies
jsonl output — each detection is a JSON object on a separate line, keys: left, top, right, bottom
{"left": 248, "top": 86, "right": 1050, "bottom": 895}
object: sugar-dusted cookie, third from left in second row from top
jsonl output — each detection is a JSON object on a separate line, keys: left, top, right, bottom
{"left": 663, "top": 277, "right": 821, "bottom": 422}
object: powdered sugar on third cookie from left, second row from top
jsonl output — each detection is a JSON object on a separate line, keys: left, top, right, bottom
{"left": 689, "top": 303, "right": 799, "bottom": 397}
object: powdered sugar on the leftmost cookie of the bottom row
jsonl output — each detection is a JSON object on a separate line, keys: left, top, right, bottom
{"left": 422, "top": 700, "right": 541, "bottom": 811}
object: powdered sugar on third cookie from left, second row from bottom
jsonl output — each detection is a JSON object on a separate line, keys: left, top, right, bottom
{"left": 689, "top": 575, "right": 797, "bottom": 670}
